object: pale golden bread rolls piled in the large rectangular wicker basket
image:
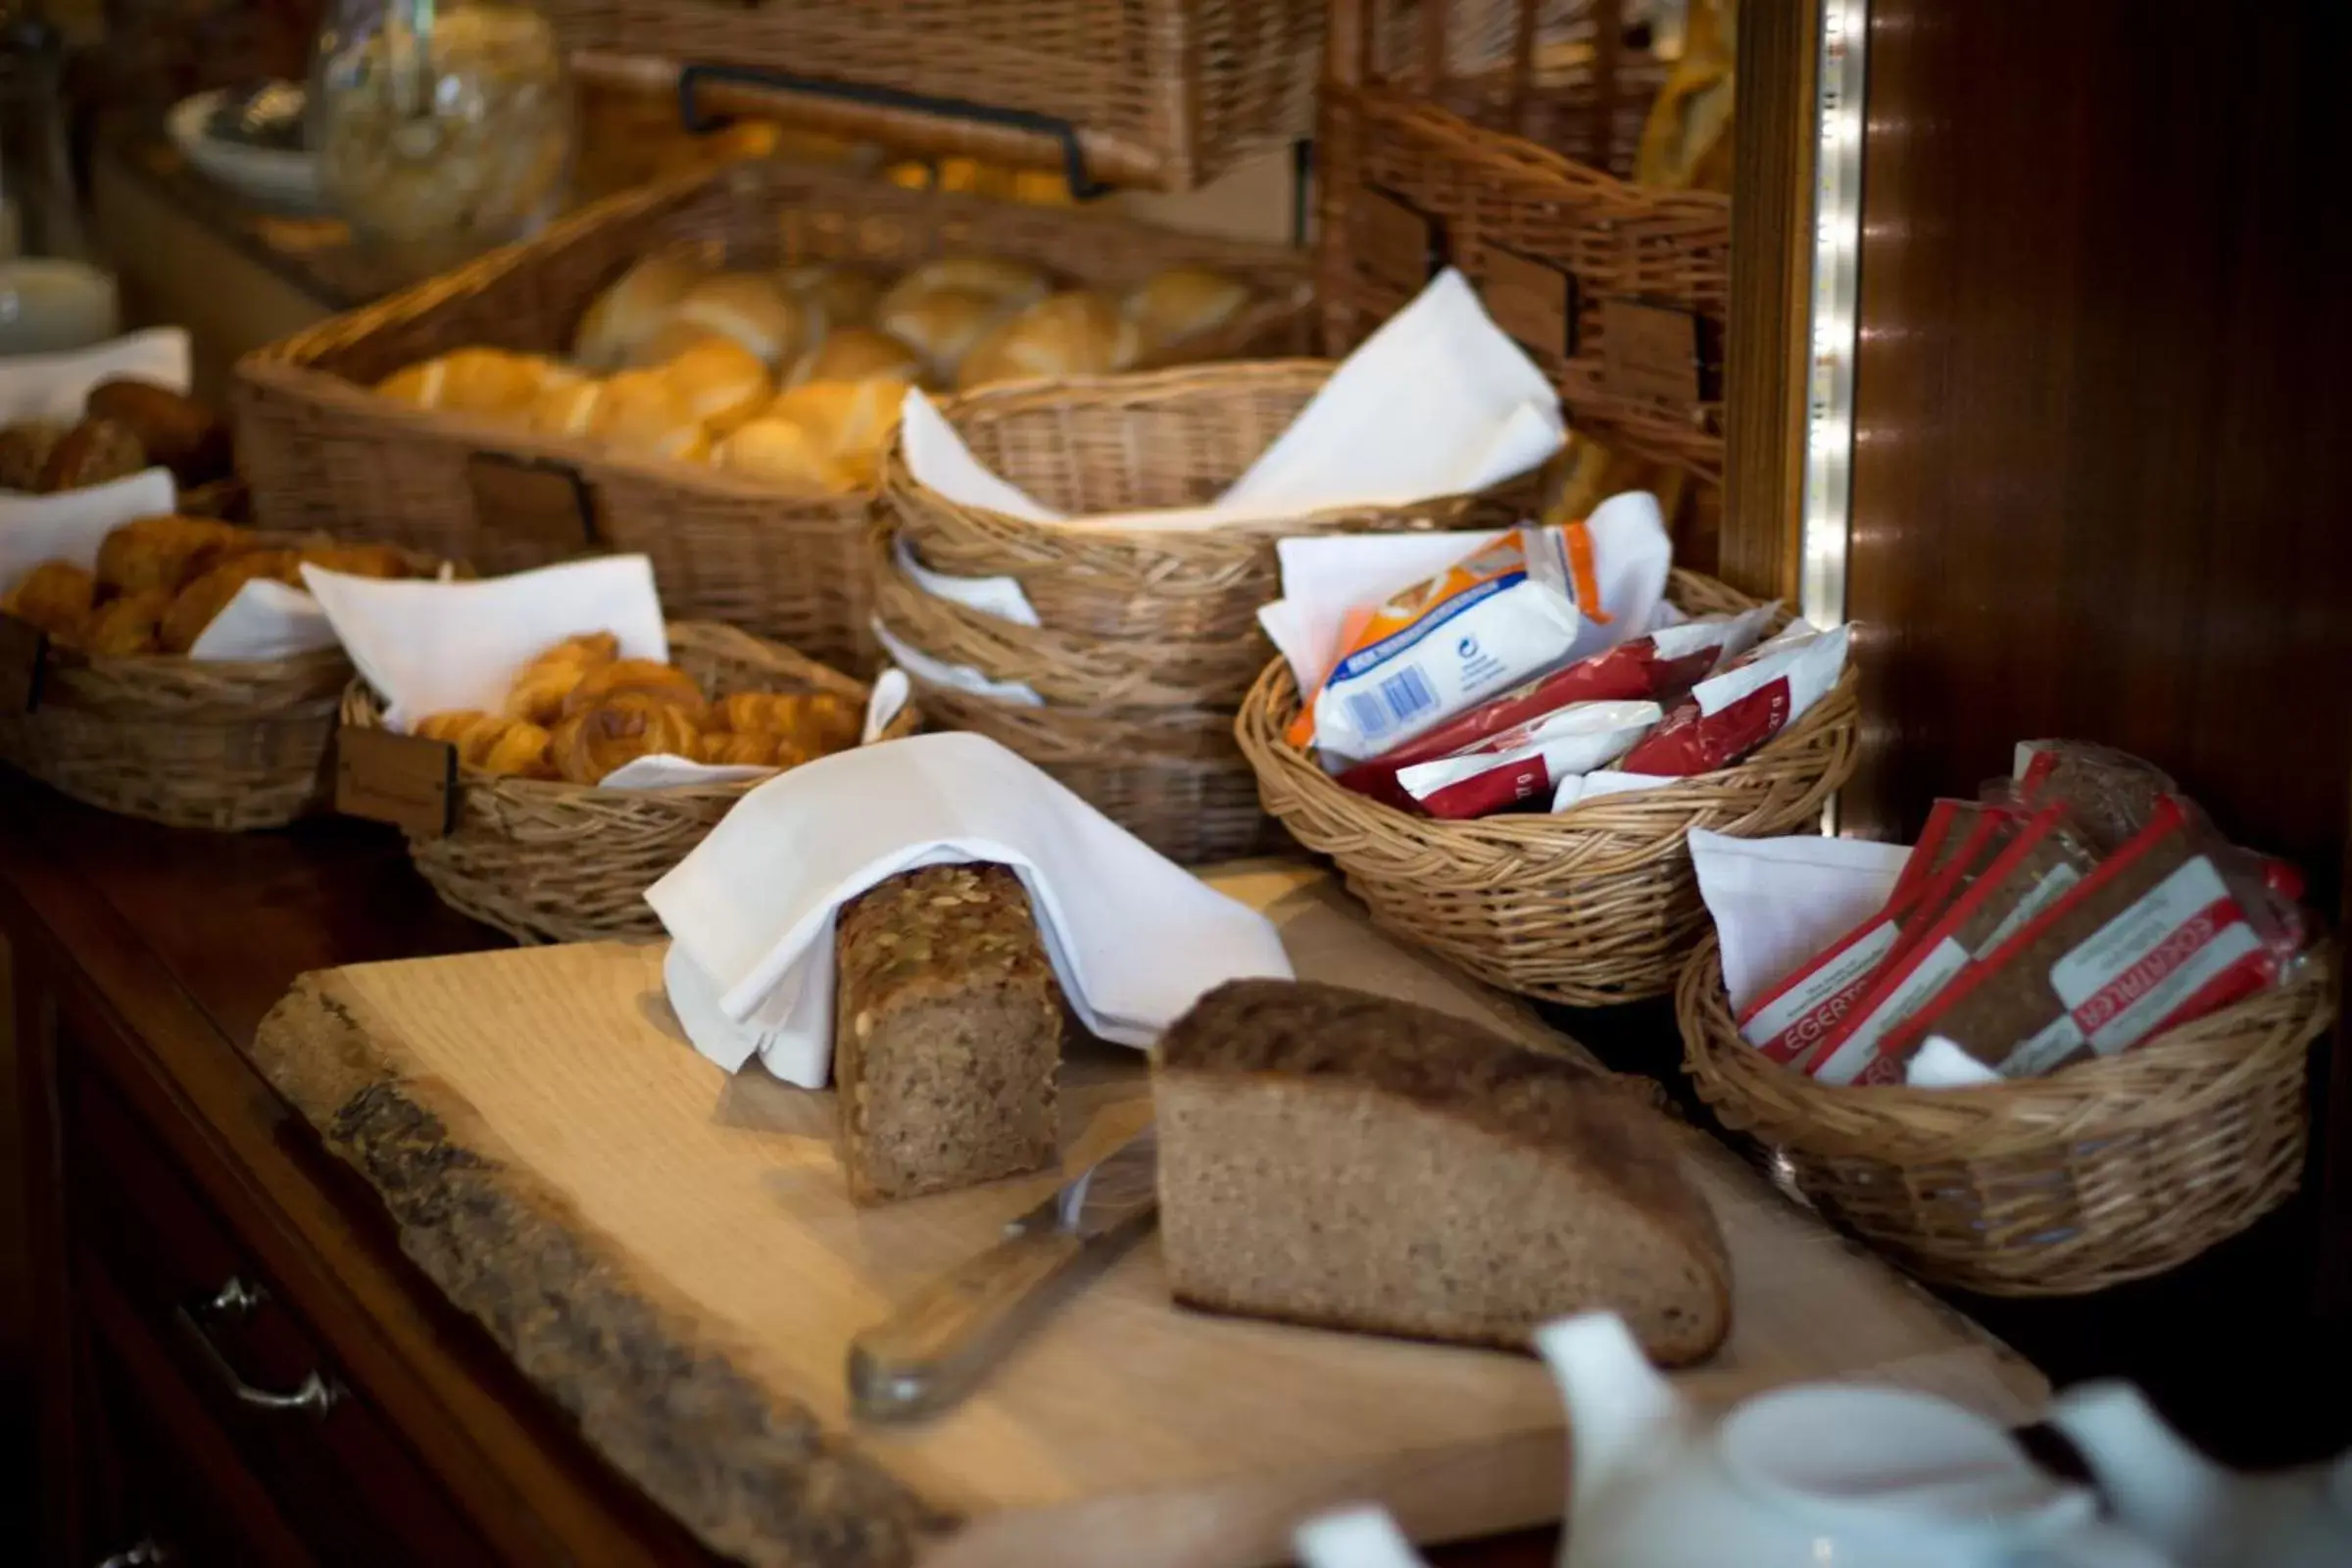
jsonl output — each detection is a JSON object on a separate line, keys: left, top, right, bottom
{"left": 376, "top": 254, "right": 1251, "bottom": 496}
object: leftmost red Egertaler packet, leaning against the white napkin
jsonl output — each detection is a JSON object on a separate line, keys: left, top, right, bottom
{"left": 1739, "top": 800, "right": 2009, "bottom": 1065}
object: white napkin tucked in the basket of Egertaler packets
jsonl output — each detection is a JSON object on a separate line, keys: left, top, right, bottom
{"left": 1691, "top": 827, "right": 1910, "bottom": 1013}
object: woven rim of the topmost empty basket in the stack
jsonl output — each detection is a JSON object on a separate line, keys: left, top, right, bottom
{"left": 882, "top": 358, "right": 1505, "bottom": 555}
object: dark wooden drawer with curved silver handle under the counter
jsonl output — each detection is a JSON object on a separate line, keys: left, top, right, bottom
{"left": 59, "top": 1051, "right": 492, "bottom": 1568}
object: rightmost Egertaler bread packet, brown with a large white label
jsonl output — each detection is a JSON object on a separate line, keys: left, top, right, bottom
{"left": 1880, "top": 797, "right": 2281, "bottom": 1079}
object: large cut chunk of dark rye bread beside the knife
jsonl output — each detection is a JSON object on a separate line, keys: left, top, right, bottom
{"left": 1152, "top": 980, "right": 1731, "bottom": 1363}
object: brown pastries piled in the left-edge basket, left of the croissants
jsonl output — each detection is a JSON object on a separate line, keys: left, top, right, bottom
{"left": 0, "top": 517, "right": 414, "bottom": 659}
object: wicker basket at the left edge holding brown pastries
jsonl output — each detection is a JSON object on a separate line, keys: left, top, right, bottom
{"left": 0, "top": 538, "right": 435, "bottom": 832}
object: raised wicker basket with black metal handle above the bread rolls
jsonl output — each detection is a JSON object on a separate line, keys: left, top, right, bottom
{"left": 541, "top": 0, "right": 1324, "bottom": 190}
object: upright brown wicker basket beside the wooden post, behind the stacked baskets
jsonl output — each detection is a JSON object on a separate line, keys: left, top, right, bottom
{"left": 1317, "top": 0, "right": 1731, "bottom": 482}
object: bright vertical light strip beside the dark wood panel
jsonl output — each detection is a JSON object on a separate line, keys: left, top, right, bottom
{"left": 1797, "top": 0, "right": 1870, "bottom": 832}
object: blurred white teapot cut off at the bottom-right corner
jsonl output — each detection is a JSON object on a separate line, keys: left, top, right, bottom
{"left": 2051, "top": 1382, "right": 2352, "bottom": 1568}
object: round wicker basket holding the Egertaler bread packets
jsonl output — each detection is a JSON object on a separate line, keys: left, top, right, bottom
{"left": 1675, "top": 933, "right": 2335, "bottom": 1296}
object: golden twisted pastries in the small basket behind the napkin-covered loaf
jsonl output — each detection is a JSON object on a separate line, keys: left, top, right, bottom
{"left": 414, "top": 632, "right": 865, "bottom": 785}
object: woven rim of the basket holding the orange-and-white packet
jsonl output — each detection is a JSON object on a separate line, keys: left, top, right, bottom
{"left": 1235, "top": 566, "right": 1860, "bottom": 851}
